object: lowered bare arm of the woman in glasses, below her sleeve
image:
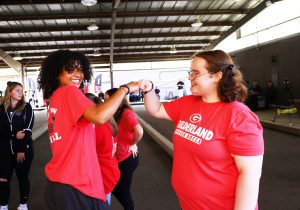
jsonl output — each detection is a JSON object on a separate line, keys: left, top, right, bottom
{"left": 233, "top": 155, "right": 263, "bottom": 210}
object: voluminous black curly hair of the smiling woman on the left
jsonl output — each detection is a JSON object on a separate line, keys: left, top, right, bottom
{"left": 37, "top": 50, "right": 93, "bottom": 99}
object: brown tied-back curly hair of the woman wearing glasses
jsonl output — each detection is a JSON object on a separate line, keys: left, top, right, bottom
{"left": 194, "top": 50, "right": 247, "bottom": 102}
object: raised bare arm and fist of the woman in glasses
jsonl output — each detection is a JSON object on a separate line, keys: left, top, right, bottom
{"left": 139, "top": 80, "right": 171, "bottom": 120}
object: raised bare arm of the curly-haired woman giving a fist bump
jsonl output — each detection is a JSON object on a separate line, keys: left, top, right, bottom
{"left": 83, "top": 82, "right": 139, "bottom": 124}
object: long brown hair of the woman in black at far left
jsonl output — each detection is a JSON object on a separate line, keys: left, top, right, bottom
{"left": 1, "top": 82, "right": 25, "bottom": 112}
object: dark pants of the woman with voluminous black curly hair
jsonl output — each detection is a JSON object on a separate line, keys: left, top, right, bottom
{"left": 45, "top": 180, "right": 110, "bottom": 210}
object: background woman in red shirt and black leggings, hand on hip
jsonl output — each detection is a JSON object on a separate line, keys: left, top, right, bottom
{"left": 105, "top": 88, "right": 143, "bottom": 210}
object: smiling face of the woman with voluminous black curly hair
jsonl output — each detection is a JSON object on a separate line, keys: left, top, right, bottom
{"left": 59, "top": 68, "right": 84, "bottom": 88}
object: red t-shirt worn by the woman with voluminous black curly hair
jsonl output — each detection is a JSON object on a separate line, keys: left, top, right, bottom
{"left": 45, "top": 86, "right": 106, "bottom": 201}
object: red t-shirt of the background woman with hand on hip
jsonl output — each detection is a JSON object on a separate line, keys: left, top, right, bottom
{"left": 116, "top": 109, "right": 139, "bottom": 162}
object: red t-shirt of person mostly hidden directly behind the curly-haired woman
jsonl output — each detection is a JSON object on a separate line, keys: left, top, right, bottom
{"left": 95, "top": 122, "right": 120, "bottom": 194}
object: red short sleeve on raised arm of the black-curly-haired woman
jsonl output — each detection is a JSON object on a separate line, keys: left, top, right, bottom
{"left": 62, "top": 86, "right": 94, "bottom": 123}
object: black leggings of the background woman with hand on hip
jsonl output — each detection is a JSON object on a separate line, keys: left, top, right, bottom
{"left": 112, "top": 155, "right": 139, "bottom": 210}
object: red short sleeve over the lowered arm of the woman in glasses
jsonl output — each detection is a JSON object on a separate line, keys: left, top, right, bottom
{"left": 227, "top": 110, "right": 264, "bottom": 156}
